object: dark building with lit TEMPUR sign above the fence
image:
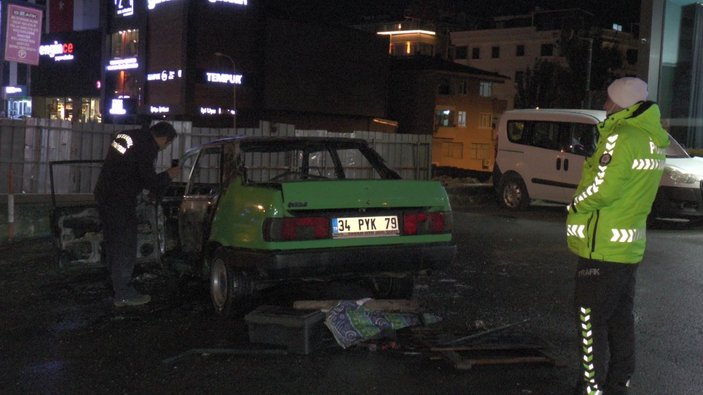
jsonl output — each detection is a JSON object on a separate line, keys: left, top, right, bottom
{"left": 98, "top": 0, "right": 388, "bottom": 131}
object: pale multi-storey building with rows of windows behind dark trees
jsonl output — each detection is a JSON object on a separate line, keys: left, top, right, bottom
{"left": 451, "top": 9, "right": 639, "bottom": 109}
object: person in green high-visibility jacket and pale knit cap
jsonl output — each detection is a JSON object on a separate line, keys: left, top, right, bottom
{"left": 566, "top": 77, "right": 669, "bottom": 394}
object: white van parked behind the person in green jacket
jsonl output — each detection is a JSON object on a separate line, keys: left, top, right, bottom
{"left": 493, "top": 109, "right": 703, "bottom": 219}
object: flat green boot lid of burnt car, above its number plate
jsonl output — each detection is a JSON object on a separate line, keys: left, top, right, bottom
{"left": 281, "top": 180, "right": 450, "bottom": 210}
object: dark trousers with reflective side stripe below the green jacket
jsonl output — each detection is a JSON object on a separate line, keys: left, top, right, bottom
{"left": 574, "top": 258, "right": 639, "bottom": 394}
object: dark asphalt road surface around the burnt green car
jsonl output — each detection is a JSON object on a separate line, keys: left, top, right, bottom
{"left": 0, "top": 202, "right": 703, "bottom": 394}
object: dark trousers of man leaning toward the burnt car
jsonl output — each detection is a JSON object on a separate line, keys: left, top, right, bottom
{"left": 98, "top": 204, "right": 137, "bottom": 299}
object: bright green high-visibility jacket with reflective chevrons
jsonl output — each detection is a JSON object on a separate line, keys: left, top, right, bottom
{"left": 566, "top": 102, "right": 669, "bottom": 264}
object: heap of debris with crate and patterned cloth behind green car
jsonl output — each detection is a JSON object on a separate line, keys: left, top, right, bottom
{"left": 242, "top": 299, "right": 557, "bottom": 370}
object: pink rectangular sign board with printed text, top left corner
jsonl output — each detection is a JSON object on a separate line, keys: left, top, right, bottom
{"left": 4, "top": 4, "right": 43, "bottom": 66}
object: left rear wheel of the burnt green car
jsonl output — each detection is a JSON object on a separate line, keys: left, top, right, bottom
{"left": 210, "top": 250, "right": 254, "bottom": 317}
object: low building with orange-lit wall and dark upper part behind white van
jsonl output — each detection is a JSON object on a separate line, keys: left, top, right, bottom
{"left": 389, "top": 56, "right": 508, "bottom": 177}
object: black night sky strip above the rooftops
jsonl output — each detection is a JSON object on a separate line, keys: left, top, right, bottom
{"left": 266, "top": 0, "right": 641, "bottom": 26}
